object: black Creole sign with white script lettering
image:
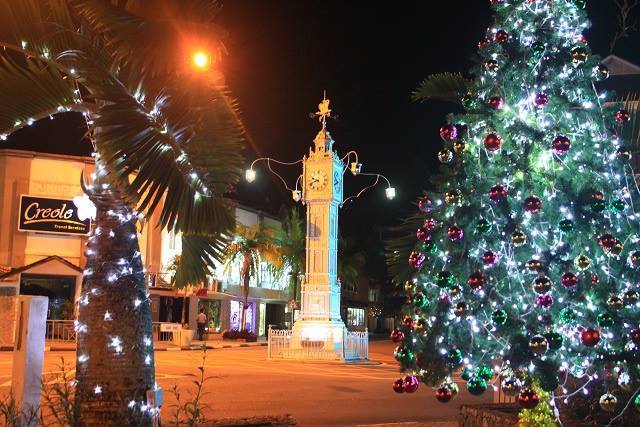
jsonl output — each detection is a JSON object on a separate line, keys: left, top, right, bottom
{"left": 18, "top": 195, "right": 91, "bottom": 235}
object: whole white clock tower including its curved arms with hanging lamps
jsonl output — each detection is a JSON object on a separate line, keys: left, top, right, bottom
{"left": 245, "top": 97, "right": 396, "bottom": 358}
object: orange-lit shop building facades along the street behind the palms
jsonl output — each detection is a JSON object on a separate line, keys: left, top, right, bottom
{"left": 0, "top": 149, "right": 289, "bottom": 335}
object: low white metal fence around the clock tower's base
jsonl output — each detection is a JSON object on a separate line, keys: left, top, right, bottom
{"left": 267, "top": 326, "right": 369, "bottom": 360}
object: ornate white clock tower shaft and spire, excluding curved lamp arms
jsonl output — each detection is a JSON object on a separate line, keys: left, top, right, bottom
{"left": 293, "top": 99, "right": 345, "bottom": 352}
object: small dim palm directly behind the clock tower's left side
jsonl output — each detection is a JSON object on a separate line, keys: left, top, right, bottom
{"left": 274, "top": 207, "right": 306, "bottom": 303}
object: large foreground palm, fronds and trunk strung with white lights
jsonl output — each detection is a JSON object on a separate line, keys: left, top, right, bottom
{"left": 0, "top": 0, "right": 243, "bottom": 425}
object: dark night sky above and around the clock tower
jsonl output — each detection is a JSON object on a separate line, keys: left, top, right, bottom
{"left": 4, "top": 0, "right": 640, "bottom": 242}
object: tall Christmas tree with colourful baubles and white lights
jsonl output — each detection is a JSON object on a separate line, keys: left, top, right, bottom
{"left": 392, "top": 0, "right": 640, "bottom": 419}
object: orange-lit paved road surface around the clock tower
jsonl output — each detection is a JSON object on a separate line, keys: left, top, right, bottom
{"left": 0, "top": 341, "right": 491, "bottom": 426}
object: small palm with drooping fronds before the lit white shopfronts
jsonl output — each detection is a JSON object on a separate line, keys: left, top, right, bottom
{"left": 223, "top": 224, "right": 282, "bottom": 330}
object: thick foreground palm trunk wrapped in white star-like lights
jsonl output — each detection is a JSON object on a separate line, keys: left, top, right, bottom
{"left": 75, "top": 190, "right": 155, "bottom": 426}
